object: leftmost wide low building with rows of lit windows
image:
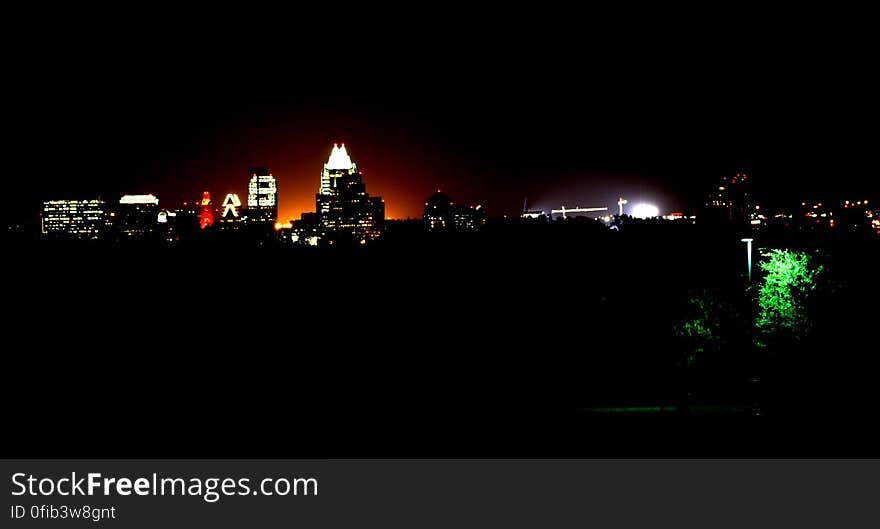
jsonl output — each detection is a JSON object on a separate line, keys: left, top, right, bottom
{"left": 41, "top": 199, "right": 114, "bottom": 239}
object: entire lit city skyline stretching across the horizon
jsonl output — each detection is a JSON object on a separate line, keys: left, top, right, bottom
{"left": 31, "top": 142, "right": 877, "bottom": 239}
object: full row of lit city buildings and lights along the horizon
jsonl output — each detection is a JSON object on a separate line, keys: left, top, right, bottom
{"left": 41, "top": 159, "right": 880, "bottom": 246}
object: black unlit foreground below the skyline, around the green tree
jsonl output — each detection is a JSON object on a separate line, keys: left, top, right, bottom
{"left": 3, "top": 221, "right": 880, "bottom": 457}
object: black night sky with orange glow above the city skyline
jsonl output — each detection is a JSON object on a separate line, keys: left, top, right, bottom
{"left": 4, "top": 7, "right": 878, "bottom": 225}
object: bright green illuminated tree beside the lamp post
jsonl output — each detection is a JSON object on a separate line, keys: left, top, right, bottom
{"left": 755, "top": 250, "right": 822, "bottom": 345}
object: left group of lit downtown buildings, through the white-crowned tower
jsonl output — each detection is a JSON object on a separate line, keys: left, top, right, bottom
{"left": 41, "top": 144, "right": 385, "bottom": 246}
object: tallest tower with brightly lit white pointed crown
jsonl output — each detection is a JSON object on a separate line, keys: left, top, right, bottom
{"left": 315, "top": 144, "right": 385, "bottom": 241}
